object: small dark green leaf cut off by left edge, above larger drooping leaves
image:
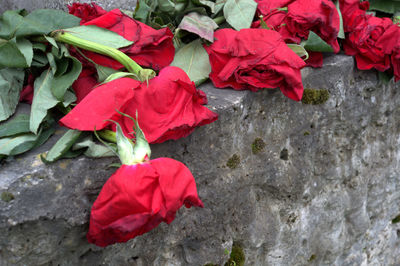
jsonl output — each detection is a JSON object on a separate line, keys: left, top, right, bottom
{"left": 0, "top": 39, "right": 28, "bottom": 68}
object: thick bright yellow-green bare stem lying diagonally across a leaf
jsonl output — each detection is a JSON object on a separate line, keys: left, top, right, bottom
{"left": 52, "top": 31, "right": 143, "bottom": 77}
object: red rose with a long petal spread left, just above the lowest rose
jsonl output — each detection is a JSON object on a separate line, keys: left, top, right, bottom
{"left": 60, "top": 66, "right": 218, "bottom": 143}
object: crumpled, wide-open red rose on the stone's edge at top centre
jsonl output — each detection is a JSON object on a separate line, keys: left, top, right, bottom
{"left": 205, "top": 29, "right": 306, "bottom": 101}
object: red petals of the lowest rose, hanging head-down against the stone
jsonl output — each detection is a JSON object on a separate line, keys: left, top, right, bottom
{"left": 87, "top": 158, "right": 203, "bottom": 247}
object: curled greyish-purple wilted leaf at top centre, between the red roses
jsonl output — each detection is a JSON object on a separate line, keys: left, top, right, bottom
{"left": 178, "top": 12, "right": 218, "bottom": 42}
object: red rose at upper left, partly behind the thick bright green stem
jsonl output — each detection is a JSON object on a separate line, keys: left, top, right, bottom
{"left": 68, "top": 4, "right": 175, "bottom": 70}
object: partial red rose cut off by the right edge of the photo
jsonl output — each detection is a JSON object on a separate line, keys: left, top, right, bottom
{"left": 376, "top": 24, "right": 400, "bottom": 81}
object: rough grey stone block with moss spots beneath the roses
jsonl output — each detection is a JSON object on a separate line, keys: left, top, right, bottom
{"left": 0, "top": 55, "right": 400, "bottom": 266}
